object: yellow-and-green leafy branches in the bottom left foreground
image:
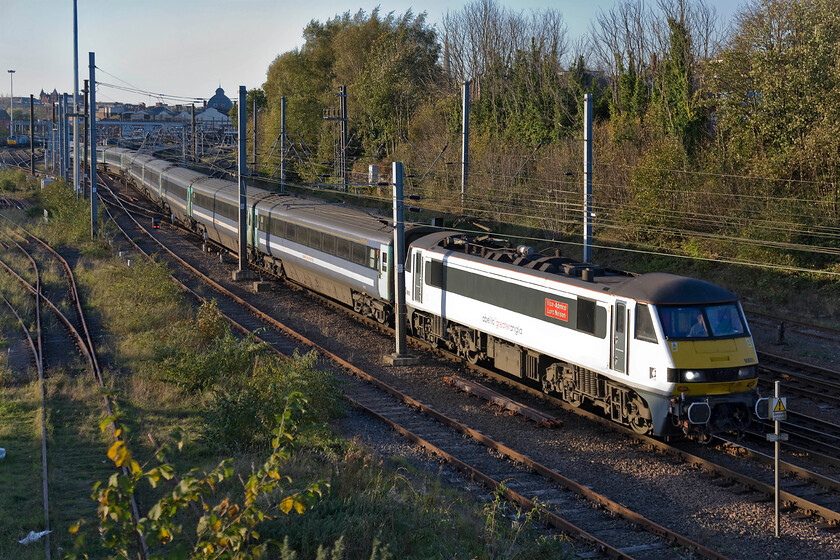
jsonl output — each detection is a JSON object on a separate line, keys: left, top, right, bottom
{"left": 69, "top": 393, "right": 328, "bottom": 559}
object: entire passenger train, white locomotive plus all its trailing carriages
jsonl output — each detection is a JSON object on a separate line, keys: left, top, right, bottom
{"left": 97, "top": 144, "right": 757, "bottom": 436}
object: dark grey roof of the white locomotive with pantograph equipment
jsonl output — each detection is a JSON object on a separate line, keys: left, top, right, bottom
{"left": 411, "top": 231, "right": 738, "bottom": 305}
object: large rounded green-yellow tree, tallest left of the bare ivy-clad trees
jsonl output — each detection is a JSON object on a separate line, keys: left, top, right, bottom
{"left": 263, "top": 9, "right": 440, "bottom": 178}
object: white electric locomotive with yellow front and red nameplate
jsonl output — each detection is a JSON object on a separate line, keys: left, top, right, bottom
{"left": 406, "top": 232, "right": 757, "bottom": 435}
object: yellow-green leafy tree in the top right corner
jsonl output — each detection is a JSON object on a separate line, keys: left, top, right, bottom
{"left": 707, "top": 0, "right": 840, "bottom": 179}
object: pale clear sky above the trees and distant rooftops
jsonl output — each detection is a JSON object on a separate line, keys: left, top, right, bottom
{"left": 0, "top": 0, "right": 742, "bottom": 104}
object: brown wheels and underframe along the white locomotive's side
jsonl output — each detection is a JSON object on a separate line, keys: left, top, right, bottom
{"left": 410, "top": 310, "right": 653, "bottom": 434}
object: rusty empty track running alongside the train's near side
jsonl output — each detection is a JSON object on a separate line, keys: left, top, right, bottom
{"left": 100, "top": 173, "right": 740, "bottom": 558}
